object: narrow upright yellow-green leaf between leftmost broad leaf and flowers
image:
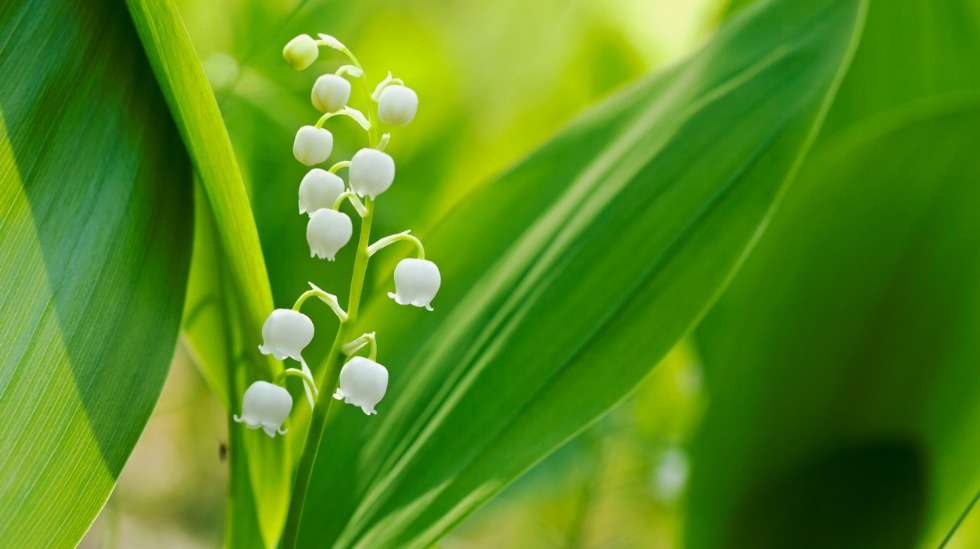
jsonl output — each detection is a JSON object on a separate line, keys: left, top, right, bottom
{"left": 127, "top": 0, "right": 290, "bottom": 546}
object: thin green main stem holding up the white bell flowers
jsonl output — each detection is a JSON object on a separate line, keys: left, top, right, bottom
{"left": 280, "top": 51, "right": 378, "bottom": 549}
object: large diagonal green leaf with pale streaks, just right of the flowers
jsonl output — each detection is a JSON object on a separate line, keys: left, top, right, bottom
{"left": 301, "top": 0, "right": 863, "bottom": 547}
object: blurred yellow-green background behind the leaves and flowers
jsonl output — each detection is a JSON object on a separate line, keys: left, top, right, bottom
{"left": 76, "top": 0, "right": 980, "bottom": 548}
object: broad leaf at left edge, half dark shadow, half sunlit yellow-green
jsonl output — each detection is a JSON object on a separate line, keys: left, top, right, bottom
{"left": 0, "top": 1, "right": 192, "bottom": 547}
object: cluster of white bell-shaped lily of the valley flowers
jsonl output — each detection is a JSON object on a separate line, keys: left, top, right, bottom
{"left": 234, "top": 34, "right": 441, "bottom": 437}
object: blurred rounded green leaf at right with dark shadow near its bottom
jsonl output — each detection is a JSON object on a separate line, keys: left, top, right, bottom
{"left": 686, "top": 100, "right": 980, "bottom": 548}
